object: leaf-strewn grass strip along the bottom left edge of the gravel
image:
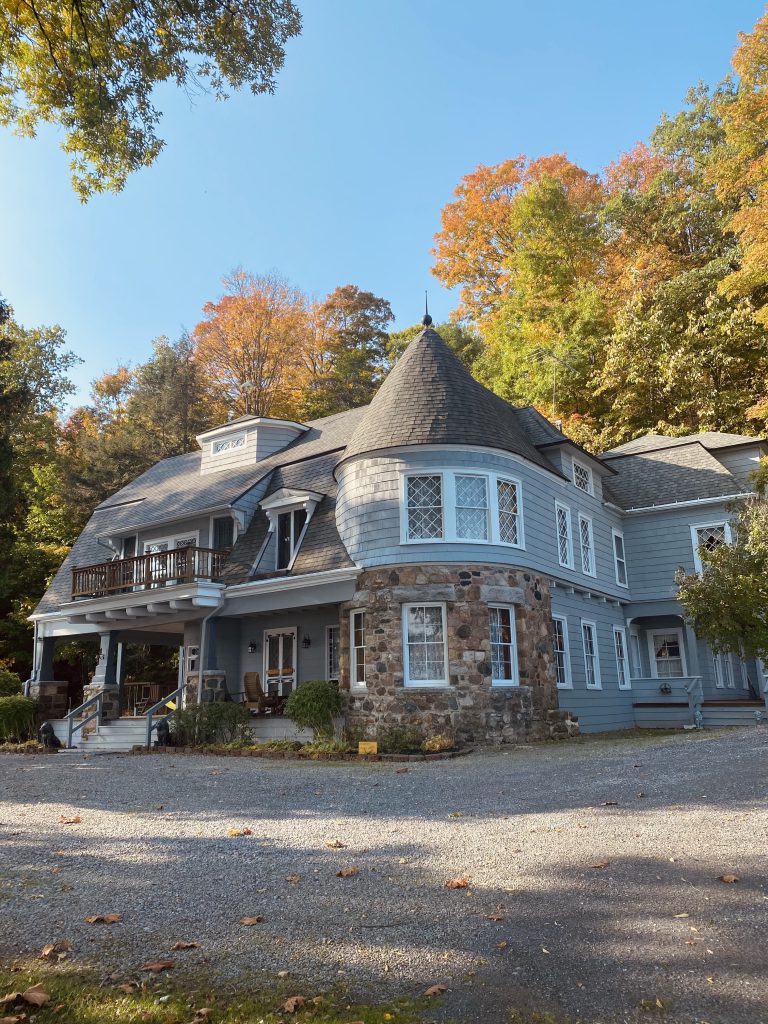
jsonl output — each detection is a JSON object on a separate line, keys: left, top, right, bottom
{"left": 0, "top": 967, "right": 425, "bottom": 1024}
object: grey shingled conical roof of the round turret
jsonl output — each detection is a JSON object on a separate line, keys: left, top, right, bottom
{"left": 340, "top": 327, "right": 552, "bottom": 471}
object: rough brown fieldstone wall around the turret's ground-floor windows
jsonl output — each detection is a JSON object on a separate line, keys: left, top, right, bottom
{"left": 340, "top": 564, "right": 579, "bottom": 743}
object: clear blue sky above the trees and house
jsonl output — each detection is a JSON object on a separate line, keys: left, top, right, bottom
{"left": 0, "top": 0, "right": 764, "bottom": 400}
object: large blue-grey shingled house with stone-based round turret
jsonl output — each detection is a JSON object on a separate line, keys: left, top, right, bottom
{"left": 31, "top": 325, "right": 768, "bottom": 742}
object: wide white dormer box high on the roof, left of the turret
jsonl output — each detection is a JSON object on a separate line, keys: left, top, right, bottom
{"left": 197, "top": 416, "right": 307, "bottom": 474}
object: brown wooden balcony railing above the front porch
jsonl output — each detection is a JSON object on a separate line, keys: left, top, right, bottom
{"left": 72, "top": 547, "right": 229, "bottom": 600}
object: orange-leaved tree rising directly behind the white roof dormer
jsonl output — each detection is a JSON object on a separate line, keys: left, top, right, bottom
{"left": 193, "top": 270, "right": 309, "bottom": 420}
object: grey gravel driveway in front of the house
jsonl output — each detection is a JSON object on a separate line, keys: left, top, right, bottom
{"left": 0, "top": 728, "right": 768, "bottom": 1024}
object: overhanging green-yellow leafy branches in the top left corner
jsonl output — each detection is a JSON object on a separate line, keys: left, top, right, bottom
{"left": 0, "top": 0, "right": 301, "bottom": 201}
